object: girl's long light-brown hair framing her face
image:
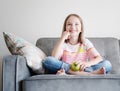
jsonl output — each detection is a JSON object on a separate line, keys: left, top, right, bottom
{"left": 62, "top": 14, "right": 84, "bottom": 44}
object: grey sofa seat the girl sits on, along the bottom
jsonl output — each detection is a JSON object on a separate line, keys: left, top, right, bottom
{"left": 23, "top": 74, "right": 120, "bottom": 91}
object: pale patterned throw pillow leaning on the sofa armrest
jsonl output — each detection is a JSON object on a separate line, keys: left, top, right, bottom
{"left": 3, "top": 32, "right": 46, "bottom": 74}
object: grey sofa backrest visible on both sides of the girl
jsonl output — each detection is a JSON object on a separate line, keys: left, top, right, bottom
{"left": 36, "top": 37, "right": 120, "bottom": 74}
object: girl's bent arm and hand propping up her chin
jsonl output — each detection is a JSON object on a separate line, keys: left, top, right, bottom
{"left": 52, "top": 31, "right": 70, "bottom": 59}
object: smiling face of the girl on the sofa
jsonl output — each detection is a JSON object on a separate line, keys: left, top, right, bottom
{"left": 66, "top": 16, "right": 81, "bottom": 37}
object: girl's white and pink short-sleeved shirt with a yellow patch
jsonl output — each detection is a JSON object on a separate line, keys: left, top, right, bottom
{"left": 62, "top": 39, "right": 99, "bottom": 64}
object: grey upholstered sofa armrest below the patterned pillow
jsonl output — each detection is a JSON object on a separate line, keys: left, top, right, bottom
{"left": 2, "top": 55, "right": 31, "bottom": 91}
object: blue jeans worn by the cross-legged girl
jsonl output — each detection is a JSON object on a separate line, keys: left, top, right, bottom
{"left": 43, "top": 56, "right": 112, "bottom": 74}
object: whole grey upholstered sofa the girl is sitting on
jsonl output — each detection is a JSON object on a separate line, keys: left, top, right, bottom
{"left": 2, "top": 37, "right": 120, "bottom": 91}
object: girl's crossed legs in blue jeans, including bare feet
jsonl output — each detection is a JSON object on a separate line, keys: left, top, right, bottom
{"left": 43, "top": 57, "right": 112, "bottom": 75}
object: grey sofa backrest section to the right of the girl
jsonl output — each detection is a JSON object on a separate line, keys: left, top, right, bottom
{"left": 89, "top": 37, "right": 120, "bottom": 74}
